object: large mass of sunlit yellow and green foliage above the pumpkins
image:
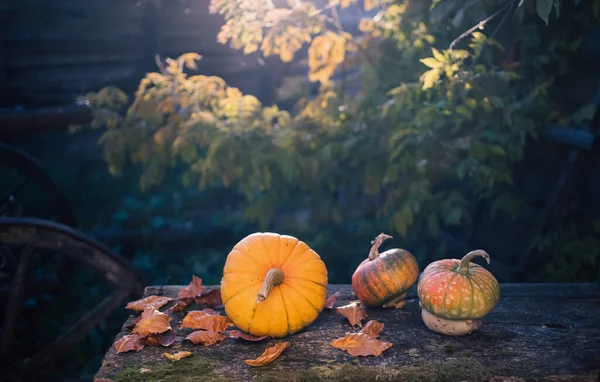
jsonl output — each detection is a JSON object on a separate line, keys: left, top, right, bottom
{"left": 76, "top": 0, "right": 600, "bottom": 280}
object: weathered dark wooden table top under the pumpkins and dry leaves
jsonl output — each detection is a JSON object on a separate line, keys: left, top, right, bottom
{"left": 95, "top": 284, "right": 600, "bottom": 382}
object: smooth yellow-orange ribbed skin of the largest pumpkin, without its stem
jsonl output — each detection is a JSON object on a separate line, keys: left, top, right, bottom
{"left": 221, "top": 233, "right": 327, "bottom": 338}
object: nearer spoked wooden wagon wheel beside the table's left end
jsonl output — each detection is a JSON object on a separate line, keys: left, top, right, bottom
{"left": 0, "top": 217, "right": 144, "bottom": 380}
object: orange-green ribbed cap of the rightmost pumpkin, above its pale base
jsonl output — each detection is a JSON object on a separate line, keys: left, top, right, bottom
{"left": 417, "top": 259, "right": 500, "bottom": 320}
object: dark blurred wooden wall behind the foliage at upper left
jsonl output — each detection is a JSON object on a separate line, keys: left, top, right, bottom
{"left": 0, "top": 0, "right": 280, "bottom": 107}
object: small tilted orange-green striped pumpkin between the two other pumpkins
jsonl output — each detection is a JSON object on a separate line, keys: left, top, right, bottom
{"left": 352, "top": 233, "right": 419, "bottom": 308}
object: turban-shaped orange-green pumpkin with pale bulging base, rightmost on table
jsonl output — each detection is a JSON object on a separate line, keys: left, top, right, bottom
{"left": 417, "top": 249, "right": 500, "bottom": 335}
